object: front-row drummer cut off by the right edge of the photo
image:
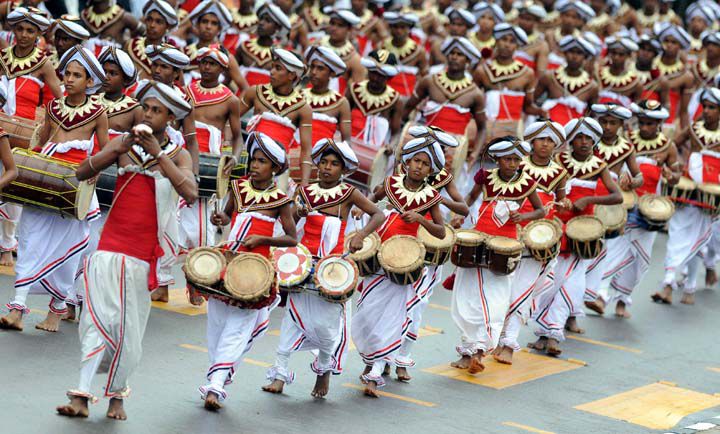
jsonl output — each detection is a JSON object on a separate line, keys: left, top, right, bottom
{"left": 653, "top": 87, "right": 720, "bottom": 304}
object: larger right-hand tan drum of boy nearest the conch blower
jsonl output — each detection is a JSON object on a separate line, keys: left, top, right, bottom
{"left": 223, "top": 252, "right": 277, "bottom": 309}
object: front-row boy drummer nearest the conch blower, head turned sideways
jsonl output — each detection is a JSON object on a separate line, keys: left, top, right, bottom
{"left": 200, "top": 133, "right": 296, "bottom": 411}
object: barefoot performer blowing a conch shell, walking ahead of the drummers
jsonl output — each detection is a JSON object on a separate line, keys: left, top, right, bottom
{"left": 57, "top": 82, "right": 197, "bottom": 420}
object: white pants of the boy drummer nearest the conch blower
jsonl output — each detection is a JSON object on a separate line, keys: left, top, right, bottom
{"left": 200, "top": 297, "right": 280, "bottom": 401}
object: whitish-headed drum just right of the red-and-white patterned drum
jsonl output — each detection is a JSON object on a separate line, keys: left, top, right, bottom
{"left": 313, "top": 255, "right": 360, "bottom": 303}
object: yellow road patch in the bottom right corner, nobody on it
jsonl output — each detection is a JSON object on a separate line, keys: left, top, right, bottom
{"left": 575, "top": 383, "right": 720, "bottom": 430}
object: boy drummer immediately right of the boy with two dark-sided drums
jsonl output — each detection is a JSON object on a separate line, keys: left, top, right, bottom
{"left": 493, "top": 121, "right": 567, "bottom": 365}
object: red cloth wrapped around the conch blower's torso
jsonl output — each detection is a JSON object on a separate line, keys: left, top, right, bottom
{"left": 97, "top": 173, "right": 163, "bottom": 289}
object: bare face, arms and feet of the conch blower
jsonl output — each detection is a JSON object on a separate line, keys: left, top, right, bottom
{"left": 56, "top": 98, "right": 198, "bottom": 420}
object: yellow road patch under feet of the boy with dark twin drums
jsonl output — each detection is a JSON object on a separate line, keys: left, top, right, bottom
{"left": 423, "top": 351, "right": 580, "bottom": 389}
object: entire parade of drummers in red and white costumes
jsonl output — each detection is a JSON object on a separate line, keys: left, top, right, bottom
{"left": 0, "top": 0, "right": 720, "bottom": 419}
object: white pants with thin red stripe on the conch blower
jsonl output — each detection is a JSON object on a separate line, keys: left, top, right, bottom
{"left": 69, "top": 251, "right": 150, "bottom": 398}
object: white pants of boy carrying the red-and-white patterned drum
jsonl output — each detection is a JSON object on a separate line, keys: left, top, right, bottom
{"left": 267, "top": 290, "right": 347, "bottom": 384}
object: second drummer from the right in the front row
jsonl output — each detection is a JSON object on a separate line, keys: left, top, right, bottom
{"left": 610, "top": 100, "right": 681, "bottom": 306}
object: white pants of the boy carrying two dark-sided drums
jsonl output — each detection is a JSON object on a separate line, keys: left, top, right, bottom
{"left": 450, "top": 268, "right": 512, "bottom": 356}
